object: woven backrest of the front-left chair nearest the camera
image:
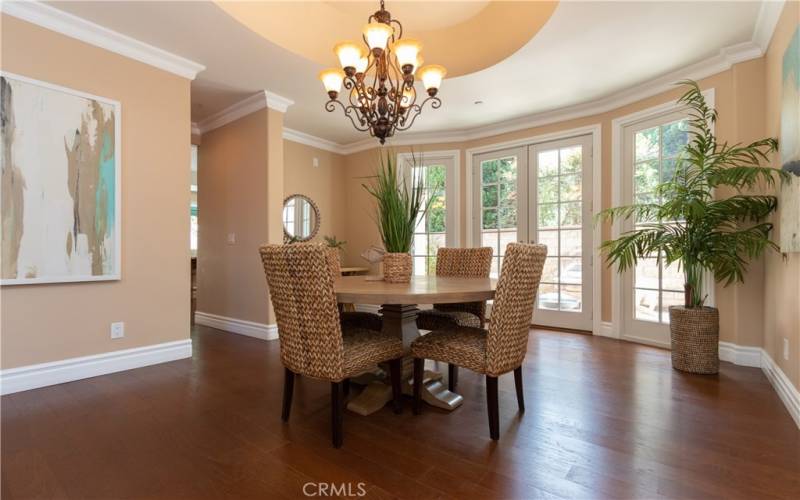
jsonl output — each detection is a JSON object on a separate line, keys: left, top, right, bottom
{"left": 259, "top": 243, "right": 344, "bottom": 381}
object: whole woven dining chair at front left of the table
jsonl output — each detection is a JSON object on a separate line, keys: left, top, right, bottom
{"left": 259, "top": 243, "right": 403, "bottom": 448}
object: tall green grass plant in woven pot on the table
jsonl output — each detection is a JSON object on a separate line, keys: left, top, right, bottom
{"left": 362, "top": 150, "right": 434, "bottom": 283}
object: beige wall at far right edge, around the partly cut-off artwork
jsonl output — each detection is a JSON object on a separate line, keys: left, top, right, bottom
{"left": 762, "top": 2, "right": 800, "bottom": 389}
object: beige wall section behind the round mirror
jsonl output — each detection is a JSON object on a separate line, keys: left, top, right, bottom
{"left": 283, "top": 140, "right": 348, "bottom": 249}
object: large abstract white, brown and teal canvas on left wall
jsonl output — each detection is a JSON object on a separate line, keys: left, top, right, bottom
{"left": 0, "top": 73, "right": 120, "bottom": 285}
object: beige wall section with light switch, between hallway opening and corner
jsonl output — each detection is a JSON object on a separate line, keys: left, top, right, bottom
{"left": 197, "top": 108, "right": 269, "bottom": 323}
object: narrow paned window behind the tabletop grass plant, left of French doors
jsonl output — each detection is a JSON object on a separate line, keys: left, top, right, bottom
{"left": 398, "top": 151, "right": 459, "bottom": 276}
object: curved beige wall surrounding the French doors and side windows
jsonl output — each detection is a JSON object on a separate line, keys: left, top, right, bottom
{"left": 345, "top": 59, "right": 764, "bottom": 346}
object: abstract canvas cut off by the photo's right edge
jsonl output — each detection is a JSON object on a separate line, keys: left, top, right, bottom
{"left": 780, "top": 28, "right": 800, "bottom": 252}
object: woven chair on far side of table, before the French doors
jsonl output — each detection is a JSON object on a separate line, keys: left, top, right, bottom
{"left": 417, "top": 247, "right": 492, "bottom": 391}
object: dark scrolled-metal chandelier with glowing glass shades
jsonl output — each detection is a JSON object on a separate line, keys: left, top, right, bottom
{"left": 319, "top": 0, "right": 446, "bottom": 144}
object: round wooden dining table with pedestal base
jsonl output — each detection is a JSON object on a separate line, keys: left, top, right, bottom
{"left": 335, "top": 276, "right": 497, "bottom": 415}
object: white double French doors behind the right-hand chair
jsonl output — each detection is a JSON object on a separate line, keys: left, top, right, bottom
{"left": 473, "top": 136, "right": 592, "bottom": 330}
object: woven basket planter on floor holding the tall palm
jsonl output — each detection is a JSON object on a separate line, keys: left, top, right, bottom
{"left": 669, "top": 306, "right": 719, "bottom": 374}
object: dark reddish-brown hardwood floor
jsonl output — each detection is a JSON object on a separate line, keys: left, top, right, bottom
{"left": 2, "top": 326, "right": 800, "bottom": 500}
